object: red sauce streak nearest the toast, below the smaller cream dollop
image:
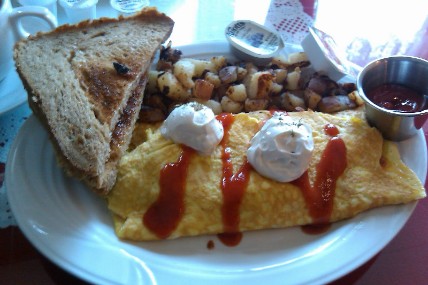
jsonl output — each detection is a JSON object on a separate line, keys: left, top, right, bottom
{"left": 143, "top": 145, "right": 195, "bottom": 239}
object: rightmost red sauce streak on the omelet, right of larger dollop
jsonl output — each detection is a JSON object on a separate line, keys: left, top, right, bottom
{"left": 292, "top": 124, "right": 347, "bottom": 234}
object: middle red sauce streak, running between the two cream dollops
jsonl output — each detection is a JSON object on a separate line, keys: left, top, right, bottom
{"left": 217, "top": 113, "right": 251, "bottom": 246}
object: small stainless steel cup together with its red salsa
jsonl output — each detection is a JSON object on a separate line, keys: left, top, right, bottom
{"left": 357, "top": 55, "right": 428, "bottom": 141}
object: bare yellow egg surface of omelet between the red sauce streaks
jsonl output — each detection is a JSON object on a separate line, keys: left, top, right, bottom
{"left": 108, "top": 109, "right": 425, "bottom": 240}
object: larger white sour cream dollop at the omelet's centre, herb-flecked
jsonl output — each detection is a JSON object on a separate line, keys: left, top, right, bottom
{"left": 247, "top": 112, "right": 314, "bottom": 182}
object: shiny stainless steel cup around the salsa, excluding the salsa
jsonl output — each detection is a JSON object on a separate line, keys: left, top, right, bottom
{"left": 357, "top": 56, "right": 428, "bottom": 141}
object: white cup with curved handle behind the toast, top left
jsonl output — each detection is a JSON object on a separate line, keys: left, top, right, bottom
{"left": 0, "top": 0, "right": 58, "bottom": 81}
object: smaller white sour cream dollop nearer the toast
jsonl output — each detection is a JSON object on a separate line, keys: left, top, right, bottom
{"left": 160, "top": 102, "right": 224, "bottom": 155}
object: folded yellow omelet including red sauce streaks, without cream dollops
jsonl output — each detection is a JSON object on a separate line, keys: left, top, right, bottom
{"left": 107, "top": 108, "right": 426, "bottom": 241}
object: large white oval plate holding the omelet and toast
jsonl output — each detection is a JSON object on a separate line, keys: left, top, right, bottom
{"left": 6, "top": 43, "right": 427, "bottom": 285}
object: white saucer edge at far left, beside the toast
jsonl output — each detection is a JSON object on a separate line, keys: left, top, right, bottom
{"left": 0, "top": 68, "right": 27, "bottom": 115}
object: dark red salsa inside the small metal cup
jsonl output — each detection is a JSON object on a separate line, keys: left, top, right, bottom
{"left": 367, "top": 84, "right": 425, "bottom": 113}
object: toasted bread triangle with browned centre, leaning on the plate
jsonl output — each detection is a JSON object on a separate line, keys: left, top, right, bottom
{"left": 14, "top": 8, "right": 174, "bottom": 194}
